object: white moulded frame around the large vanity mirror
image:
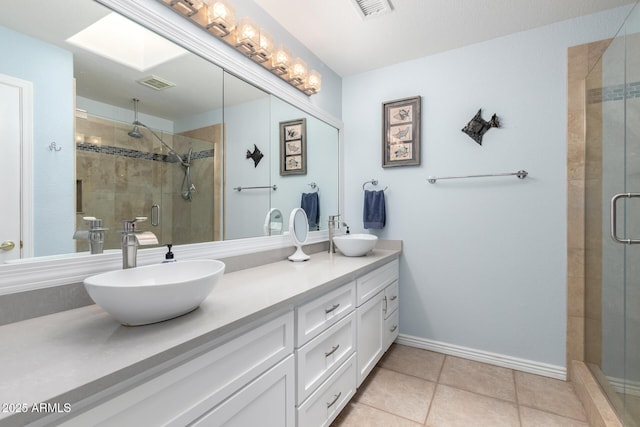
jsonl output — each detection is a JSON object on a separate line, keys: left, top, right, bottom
{"left": 0, "top": 0, "right": 344, "bottom": 295}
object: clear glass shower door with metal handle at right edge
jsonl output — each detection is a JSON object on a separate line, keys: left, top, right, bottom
{"left": 586, "top": 3, "right": 640, "bottom": 425}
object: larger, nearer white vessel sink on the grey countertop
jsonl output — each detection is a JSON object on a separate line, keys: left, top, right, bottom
{"left": 84, "top": 259, "right": 225, "bottom": 326}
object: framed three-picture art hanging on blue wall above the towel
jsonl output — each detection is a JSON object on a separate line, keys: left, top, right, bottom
{"left": 382, "top": 96, "right": 421, "bottom": 168}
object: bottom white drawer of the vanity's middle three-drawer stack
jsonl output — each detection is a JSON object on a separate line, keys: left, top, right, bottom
{"left": 297, "top": 355, "right": 356, "bottom": 427}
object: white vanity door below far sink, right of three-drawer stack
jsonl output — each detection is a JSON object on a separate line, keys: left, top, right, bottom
{"left": 356, "top": 291, "right": 385, "bottom": 387}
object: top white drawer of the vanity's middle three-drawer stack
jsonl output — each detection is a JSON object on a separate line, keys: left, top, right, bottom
{"left": 296, "top": 281, "right": 356, "bottom": 347}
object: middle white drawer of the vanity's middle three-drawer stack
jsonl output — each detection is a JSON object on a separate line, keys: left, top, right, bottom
{"left": 296, "top": 312, "right": 356, "bottom": 404}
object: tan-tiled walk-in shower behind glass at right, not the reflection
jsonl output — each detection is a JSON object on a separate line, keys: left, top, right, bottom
{"left": 584, "top": 4, "right": 640, "bottom": 426}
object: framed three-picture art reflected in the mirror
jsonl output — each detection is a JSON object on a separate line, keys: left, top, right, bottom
{"left": 280, "top": 118, "right": 307, "bottom": 176}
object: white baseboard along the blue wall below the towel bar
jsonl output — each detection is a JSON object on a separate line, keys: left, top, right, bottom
{"left": 395, "top": 334, "right": 567, "bottom": 381}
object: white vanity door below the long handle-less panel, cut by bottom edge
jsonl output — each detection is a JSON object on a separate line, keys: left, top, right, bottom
{"left": 190, "top": 355, "right": 295, "bottom": 427}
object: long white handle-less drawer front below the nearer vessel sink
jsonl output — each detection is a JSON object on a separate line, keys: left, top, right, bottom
{"left": 57, "top": 311, "right": 293, "bottom": 426}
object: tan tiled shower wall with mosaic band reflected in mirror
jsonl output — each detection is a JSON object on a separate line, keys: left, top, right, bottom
{"left": 76, "top": 116, "right": 220, "bottom": 251}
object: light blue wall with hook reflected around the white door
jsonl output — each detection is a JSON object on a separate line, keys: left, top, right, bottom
{"left": 0, "top": 27, "right": 75, "bottom": 256}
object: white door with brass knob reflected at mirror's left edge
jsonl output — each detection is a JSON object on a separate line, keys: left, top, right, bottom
{"left": 0, "top": 74, "right": 32, "bottom": 263}
